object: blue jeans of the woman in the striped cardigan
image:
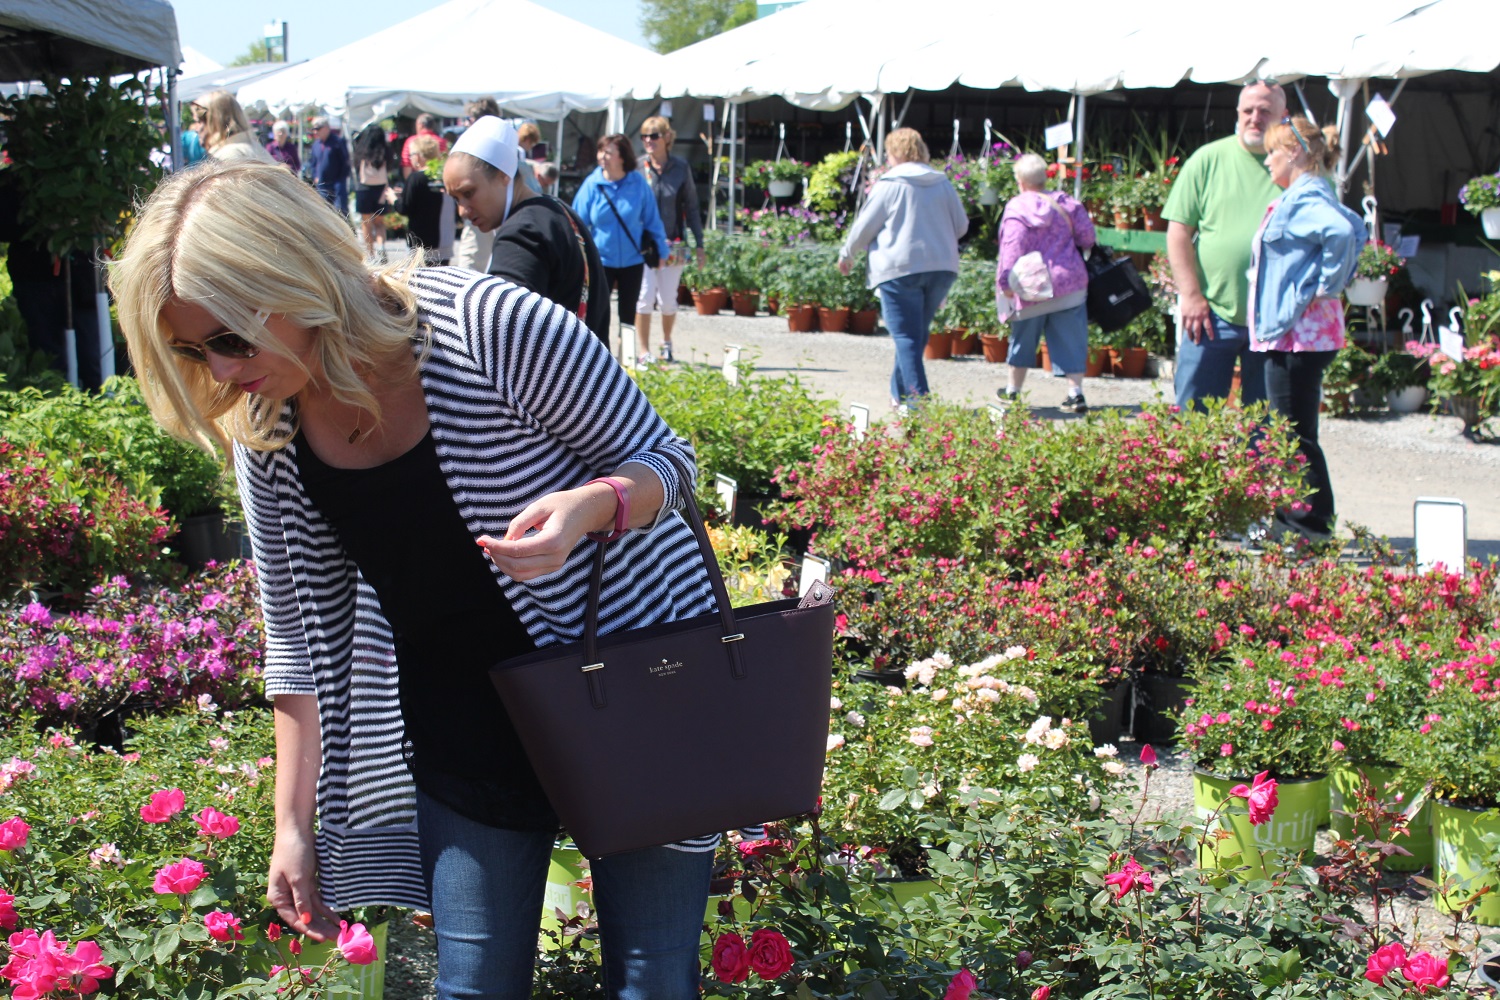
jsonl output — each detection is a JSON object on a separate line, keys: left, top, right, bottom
{"left": 417, "top": 792, "right": 714, "bottom": 1000}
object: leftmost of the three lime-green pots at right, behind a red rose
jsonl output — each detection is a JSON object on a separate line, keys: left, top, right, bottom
{"left": 1193, "top": 768, "right": 1328, "bottom": 879}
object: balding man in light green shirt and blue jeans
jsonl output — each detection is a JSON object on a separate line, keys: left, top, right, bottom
{"left": 1161, "top": 81, "right": 1287, "bottom": 409}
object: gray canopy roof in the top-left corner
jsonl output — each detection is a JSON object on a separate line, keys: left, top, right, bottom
{"left": 0, "top": 0, "right": 182, "bottom": 81}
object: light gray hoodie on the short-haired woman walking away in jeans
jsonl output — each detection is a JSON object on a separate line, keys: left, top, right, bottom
{"left": 839, "top": 163, "right": 969, "bottom": 288}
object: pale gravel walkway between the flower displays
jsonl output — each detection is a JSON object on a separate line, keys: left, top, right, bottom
{"left": 636, "top": 307, "right": 1500, "bottom": 556}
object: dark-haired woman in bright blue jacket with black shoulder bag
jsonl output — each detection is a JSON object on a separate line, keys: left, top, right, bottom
{"left": 573, "top": 133, "right": 668, "bottom": 364}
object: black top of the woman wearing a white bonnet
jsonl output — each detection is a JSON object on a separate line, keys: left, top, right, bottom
{"left": 489, "top": 195, "right": 609, "bottom": 346}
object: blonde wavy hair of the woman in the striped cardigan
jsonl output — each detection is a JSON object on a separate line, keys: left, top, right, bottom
{"left": 110, "top": 160, "right": 425, "bottom": 453}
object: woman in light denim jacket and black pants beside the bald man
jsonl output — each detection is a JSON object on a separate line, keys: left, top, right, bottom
{"left": 1250, "top": 117, "right": 1365, "bottom": 541}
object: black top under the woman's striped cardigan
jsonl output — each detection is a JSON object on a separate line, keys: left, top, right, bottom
{"left": 293, "top": 428, "right": 558, "bottom": 831}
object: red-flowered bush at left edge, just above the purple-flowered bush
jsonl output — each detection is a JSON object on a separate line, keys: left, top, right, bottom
{"left": 0, "top": 438, "right": 171, "bottom": 601}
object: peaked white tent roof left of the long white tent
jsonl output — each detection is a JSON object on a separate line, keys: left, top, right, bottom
{"left": 239, "top": 0, "right": 662, "bottom": 126}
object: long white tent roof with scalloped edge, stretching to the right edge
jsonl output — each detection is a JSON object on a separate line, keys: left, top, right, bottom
{"left": 630, "top": 0, "right": 1500, "bottom": 109}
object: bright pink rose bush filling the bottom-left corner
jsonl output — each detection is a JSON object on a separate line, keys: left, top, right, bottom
{"left": 0, "top": 707, "right": 374, "bottom": 1000}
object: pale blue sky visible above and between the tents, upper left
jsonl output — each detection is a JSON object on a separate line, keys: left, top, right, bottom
{"left": 173, "top": 0, "right": 650, "bottom": 64}
